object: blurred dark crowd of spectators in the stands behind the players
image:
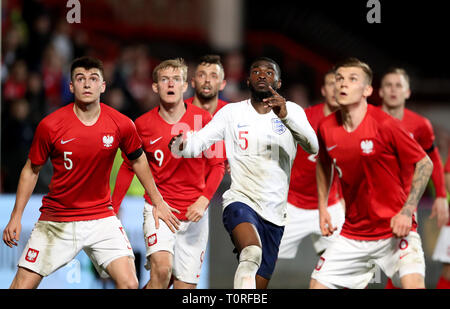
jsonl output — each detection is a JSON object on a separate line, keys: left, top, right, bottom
{"left": 0, "top": 0, "right": 320, "bottom": 193}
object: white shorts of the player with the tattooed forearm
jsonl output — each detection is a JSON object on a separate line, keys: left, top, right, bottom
{"left": 311, "top": 232, "right": 425, "bottom": 289}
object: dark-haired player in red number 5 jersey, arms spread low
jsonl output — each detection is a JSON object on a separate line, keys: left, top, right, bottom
{"left": 3, "top": 57, "right": 177, "bottom": 288}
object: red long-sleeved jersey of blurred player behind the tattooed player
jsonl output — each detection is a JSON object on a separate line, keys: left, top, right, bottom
{"left": 400, "top": 108, "right": 447, "bottom": 197}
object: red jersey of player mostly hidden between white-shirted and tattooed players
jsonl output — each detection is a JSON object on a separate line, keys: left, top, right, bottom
{"left": 288, "top": 103, "right": 339, "bottom": 209}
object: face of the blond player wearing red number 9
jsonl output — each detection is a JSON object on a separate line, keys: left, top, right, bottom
{"left": 152, "top": 67, "right": 187, "bottom": 104}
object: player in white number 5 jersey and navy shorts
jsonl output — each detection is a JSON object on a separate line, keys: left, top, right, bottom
{"left": 170, "top": 57, "right": 318, "bottom": 288}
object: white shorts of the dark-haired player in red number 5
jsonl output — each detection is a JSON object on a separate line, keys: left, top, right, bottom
{"left": 18, "top": 216, "right": 134, "bottom": 278}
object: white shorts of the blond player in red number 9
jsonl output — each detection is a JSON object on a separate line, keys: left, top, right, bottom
{"left": 144, "top": 202, "right": 209, "bottom": 284}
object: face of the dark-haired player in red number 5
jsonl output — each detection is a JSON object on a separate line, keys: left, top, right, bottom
{"left": 69, "top": 68, "right": 106, "bottom": 104}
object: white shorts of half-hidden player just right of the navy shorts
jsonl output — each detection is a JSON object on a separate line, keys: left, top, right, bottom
{"left": 278, "top": 202, "right": 345, "bottom": 259}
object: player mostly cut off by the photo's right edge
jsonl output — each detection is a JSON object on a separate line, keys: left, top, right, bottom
{"left": 433, "top": 148, "right": 450, "bottom": 289}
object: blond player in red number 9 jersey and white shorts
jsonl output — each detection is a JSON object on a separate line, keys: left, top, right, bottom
{"left": 113, "top": 59, "right": 225, "bottom": 288}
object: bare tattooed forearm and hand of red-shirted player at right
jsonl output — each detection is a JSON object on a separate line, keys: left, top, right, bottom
{"left": 391, "top": 156, "right": 433, "bottom": 237}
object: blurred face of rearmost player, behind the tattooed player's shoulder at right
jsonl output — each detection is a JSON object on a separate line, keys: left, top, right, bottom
{"left": 379, "top": 73, "right": 411, "bottom": 107}
